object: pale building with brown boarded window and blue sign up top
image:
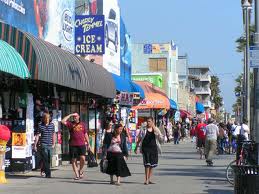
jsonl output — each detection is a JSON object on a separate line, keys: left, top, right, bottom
{"left": 132, "top": 42, "right": 179, "bottom": 102}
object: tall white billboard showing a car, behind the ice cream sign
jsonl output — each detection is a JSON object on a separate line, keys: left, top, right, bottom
{"left": 103, "top": 0, "right": 120, "bottom": 75}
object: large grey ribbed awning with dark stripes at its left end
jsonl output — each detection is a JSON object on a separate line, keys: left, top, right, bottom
{"left": 0, "top": 23, "right": 116, "bottom": 98}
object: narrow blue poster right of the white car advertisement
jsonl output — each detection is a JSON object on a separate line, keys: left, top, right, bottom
{"left": 120, "top": 18, "right": 132, "bottom": 80}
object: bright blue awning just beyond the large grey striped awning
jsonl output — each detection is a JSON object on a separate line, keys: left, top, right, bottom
{"left": 112, "top": 74, "right": 145, "bottom": 98}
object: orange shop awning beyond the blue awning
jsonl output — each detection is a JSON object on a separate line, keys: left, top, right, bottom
{"left": 132, "top": 81, "right": 170, "bottom": 110}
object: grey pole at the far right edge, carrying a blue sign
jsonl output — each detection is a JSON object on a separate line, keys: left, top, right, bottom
{"left": 253, "top": 0, "right": 259, "bottom": 164}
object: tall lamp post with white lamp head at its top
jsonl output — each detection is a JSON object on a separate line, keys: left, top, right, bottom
{"left": 242, "top": 0, "right": 252, "bottom": 128}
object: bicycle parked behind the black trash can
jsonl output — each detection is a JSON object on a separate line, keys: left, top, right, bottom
{"left": 226, "top": 141, "right": 256, "bottom": 185}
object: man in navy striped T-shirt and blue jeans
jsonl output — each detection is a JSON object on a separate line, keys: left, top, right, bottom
{"left": 34, "top": 113, "right": 55, "bottom": 178}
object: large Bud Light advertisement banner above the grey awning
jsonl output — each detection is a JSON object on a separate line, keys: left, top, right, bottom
{"left": 0, "top": 0, "right": 75, "bottom": 52}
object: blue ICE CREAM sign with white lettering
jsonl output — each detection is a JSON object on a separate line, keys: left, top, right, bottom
{"left": 75, "top": 15, "right": 105, "bottom": 55}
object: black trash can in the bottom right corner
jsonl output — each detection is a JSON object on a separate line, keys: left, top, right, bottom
{"left": 232, "top": 165, "right": 259, "bottom": 194}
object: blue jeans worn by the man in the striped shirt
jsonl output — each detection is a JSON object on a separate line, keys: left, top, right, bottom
{"left": 41, "top": 144, "right": 52, "bottom": 177}
